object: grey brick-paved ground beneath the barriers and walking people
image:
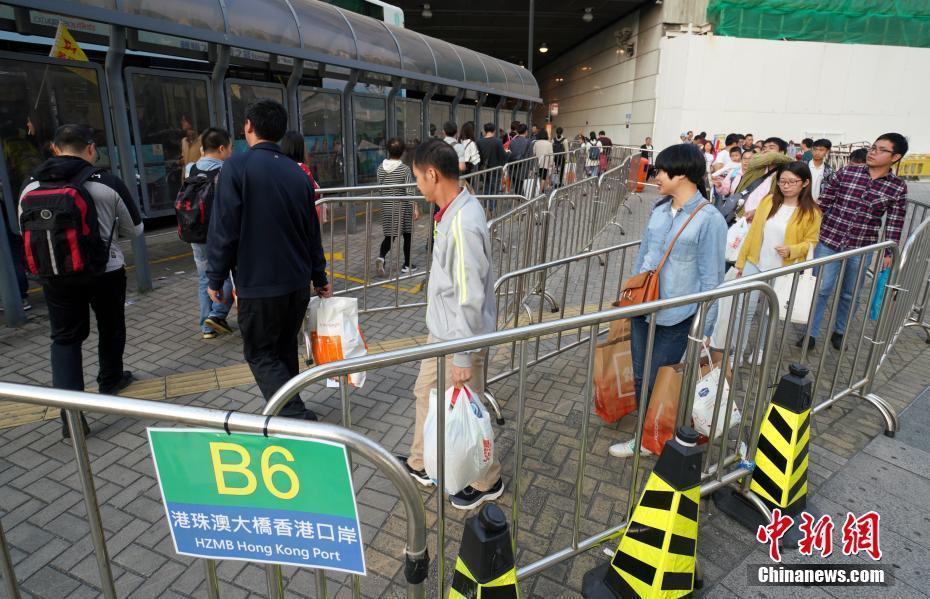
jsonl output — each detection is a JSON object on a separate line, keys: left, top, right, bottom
{"left": 0, "top": 184, "right": 930, "bottom": 598}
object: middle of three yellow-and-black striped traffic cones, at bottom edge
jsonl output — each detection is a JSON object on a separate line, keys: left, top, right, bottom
{"left": 582, "top": 426, "right": 703, "bottom": 599}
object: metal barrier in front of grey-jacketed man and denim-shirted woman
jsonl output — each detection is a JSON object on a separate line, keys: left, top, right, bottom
{"left": 265, "top": 281, "right": 778, "bottom": 594}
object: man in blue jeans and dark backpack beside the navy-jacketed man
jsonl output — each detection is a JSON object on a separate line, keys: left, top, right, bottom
{"left": 174, "top": 127, "right": 232, "bottom": 339}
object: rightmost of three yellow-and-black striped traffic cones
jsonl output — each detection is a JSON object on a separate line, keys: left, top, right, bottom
{"left": 714, "top": 364, "right": 813, "bottom": 542}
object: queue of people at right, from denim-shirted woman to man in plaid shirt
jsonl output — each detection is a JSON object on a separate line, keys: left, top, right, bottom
{"left": 609, "top": 131, "right": 908, "bottom": 457}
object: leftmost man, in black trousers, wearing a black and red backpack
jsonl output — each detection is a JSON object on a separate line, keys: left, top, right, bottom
{"left": 19, "top": 125, "right": 142, "bottom": 438}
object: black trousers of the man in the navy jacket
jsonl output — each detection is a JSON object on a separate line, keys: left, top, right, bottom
{"left": 239, "top": 285, "right": 310, "bottom": 417}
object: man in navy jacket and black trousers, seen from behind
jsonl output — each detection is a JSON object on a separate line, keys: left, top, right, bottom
{"left": 207, "top": 100, "right": 332, "bottom": 420}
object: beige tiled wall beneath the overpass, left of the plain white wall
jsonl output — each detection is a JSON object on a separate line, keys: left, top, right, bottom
{"left": 533, "top": 7, "right": 662, "bottom": 146}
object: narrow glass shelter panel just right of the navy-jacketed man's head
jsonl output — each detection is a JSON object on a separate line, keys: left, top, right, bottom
{"left": 300, "top": 89, "right": 345, "bottom": 187}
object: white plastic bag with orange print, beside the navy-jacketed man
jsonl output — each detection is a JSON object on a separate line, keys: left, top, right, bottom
{"left": 307, "top": 297, "right": 368, "bottom": 387}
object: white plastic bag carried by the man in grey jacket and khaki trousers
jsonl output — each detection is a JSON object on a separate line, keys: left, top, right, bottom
{"left": 423, "top": 386, "right": 494, "bottom": 494}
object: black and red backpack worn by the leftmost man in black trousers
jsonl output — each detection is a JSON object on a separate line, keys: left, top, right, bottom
{"left": 19, "top": 168, "right": 116, "bottom": 278}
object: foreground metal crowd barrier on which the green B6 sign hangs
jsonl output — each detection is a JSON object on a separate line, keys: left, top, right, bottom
{"left": 0, "top": 382, "right": 428, "bottom": 599}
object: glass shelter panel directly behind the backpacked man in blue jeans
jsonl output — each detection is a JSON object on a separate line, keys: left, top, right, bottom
{"left": 130, "top": 73, "right": 210, "bottom": 216}
